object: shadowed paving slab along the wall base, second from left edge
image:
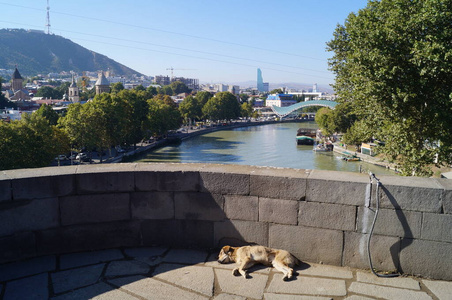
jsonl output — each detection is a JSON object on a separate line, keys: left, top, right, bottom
{"left": 60, "top": 249, "right": 124, "bottom": 270}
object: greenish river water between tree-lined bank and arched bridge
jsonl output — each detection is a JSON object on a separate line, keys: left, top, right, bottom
{"left": 136, "top": 122, "right": 394, "bottom": 175}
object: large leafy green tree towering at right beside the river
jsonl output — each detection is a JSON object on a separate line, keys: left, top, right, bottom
{"left": 327, "top": 0, "right": 452, "bottom": 176}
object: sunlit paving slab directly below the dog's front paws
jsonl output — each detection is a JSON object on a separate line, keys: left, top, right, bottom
{"left": 215, "top": 269, "right": 268, "bottom": 299}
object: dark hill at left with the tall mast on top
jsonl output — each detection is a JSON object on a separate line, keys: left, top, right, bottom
{"left": 0, "top": 29, "right": 142, "bottom": 76}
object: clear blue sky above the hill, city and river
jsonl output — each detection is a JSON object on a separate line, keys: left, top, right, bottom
{"left": 0, "top": 0, "right": 367, "bottom": 85}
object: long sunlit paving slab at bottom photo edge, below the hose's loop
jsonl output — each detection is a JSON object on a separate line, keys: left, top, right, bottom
{"left": 349, "top": 282, "right": 432, "bottom": 300}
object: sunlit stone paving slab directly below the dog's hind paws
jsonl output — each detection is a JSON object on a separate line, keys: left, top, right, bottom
{"left": 267, "top": 274, "right": 347, "bottom": 296}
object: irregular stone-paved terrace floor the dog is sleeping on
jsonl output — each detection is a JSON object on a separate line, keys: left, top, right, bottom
{"left": 0, "top": 247, "right": 452, "bottom": 300}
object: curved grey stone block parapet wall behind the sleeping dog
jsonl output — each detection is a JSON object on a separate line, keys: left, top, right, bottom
{"left": 0, "top": 164, "right": 452, "bottom": 280}
